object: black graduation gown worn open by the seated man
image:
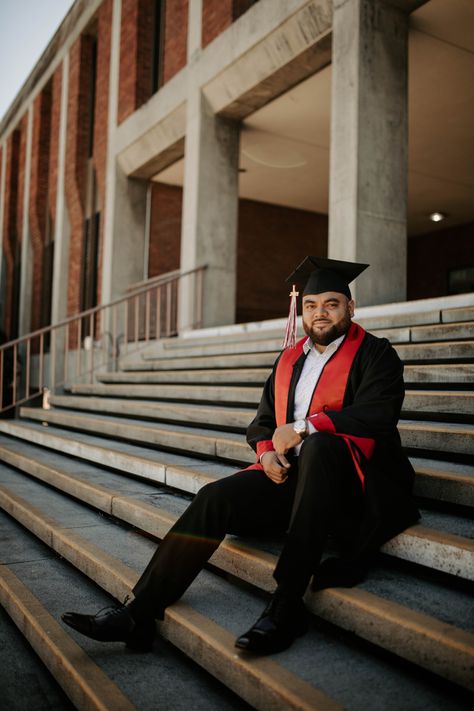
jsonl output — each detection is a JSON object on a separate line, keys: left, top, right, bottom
{"left": 247, "top": 333, "right": 419, "bottom": 572}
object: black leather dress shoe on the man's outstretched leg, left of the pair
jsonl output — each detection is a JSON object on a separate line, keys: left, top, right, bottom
{"left": 61, "top": 605, "right": 155, "bottom": 652}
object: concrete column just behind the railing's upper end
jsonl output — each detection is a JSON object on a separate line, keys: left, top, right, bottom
{"left": 179, "top": 88, "right": 240, "bottom": 331}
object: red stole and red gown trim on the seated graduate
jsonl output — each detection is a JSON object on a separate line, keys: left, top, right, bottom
{"left": 252, "top": 323, "right": 375, "bottom": 485}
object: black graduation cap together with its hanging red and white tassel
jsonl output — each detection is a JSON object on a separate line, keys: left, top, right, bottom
{"left": 283, "top": 256, "right": 369, "bottom": 348}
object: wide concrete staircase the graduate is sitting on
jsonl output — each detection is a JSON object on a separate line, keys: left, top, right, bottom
{"left": 0, "top": 295, "right": 474, "bottom": 711}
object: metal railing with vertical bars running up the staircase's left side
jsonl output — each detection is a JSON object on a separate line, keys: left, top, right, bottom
{"left": 0, "top": 267, "right": 206, "bottom": 413}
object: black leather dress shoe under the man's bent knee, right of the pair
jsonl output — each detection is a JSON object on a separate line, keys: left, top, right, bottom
{"left": 235, "top": 590, "right": 308, "bottom": 654}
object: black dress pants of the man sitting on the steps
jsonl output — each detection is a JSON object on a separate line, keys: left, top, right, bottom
{"left": 131, "top": 432, "right": 363, "bottom": 619}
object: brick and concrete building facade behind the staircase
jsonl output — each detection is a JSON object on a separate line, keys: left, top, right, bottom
{"left": 0, "top": 0, "right": 474, "bottom": 339}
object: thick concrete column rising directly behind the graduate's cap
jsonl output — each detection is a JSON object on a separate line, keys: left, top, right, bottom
{"left": 328, "top": 0, "right": 408, "bottom": 306}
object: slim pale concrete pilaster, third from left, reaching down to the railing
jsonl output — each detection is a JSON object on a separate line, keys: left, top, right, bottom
{"left": 51, "top": 54, "right": 71, "bottom": 323}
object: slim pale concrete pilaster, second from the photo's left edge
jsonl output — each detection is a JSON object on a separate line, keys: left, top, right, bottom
{"left": 18, "top": 102, "right": 34, "bottom": 336}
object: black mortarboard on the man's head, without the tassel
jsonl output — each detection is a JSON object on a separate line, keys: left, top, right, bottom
{"left": 286, "top": 256, "right": 369, "bottom": 299}
